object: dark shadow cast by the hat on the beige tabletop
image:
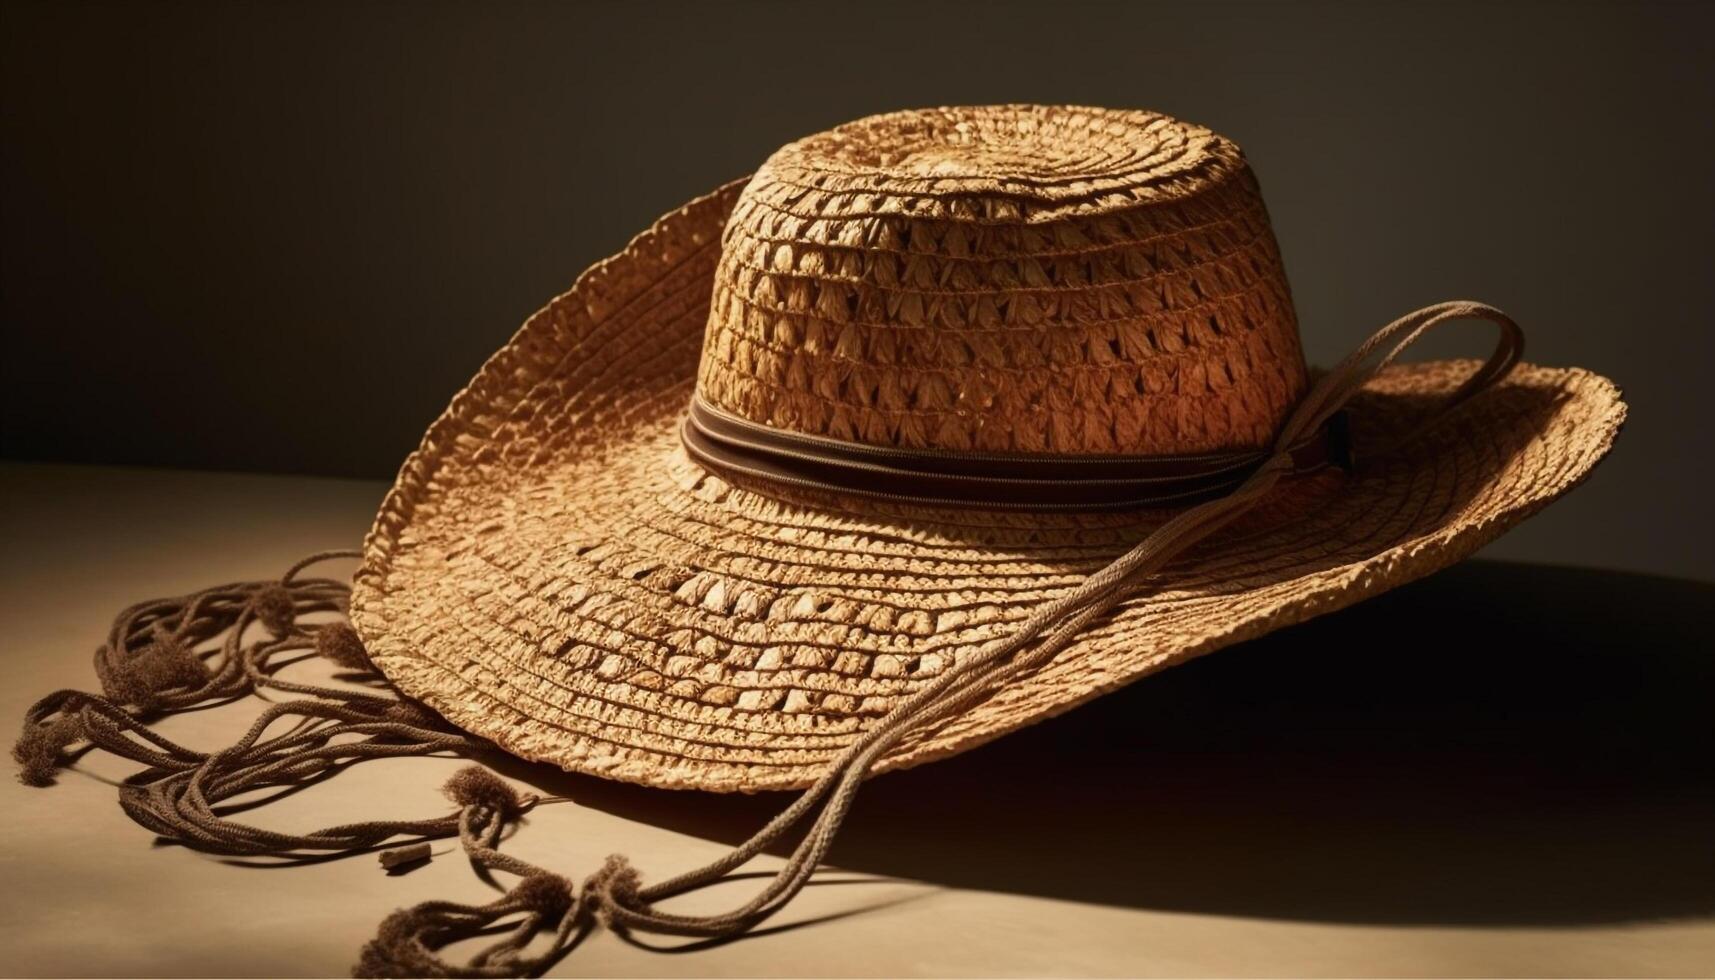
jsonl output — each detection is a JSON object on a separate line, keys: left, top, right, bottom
{"left": 499, "top": 561, "right": 1715, "bottom": 925}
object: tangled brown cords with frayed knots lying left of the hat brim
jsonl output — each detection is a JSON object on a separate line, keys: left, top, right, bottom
{"left": 12, "top": 553, "right": 511, "bottom": 858}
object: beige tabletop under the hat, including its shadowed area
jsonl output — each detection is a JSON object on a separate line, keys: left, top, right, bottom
{"left": 0, "top": 465, "right": 1715, "bottom": 977}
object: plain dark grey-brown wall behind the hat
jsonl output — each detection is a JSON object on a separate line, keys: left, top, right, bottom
{"left": 0, "top": 0, "right": 1715, "bottom": 578}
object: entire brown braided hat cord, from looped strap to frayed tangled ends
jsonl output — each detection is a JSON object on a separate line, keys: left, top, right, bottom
{"left": 14, "top": 300, "right": 1523, "bottom": 977}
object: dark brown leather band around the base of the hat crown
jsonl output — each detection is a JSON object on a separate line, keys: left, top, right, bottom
{"left": 679, "top": 395, "right": 1351, "bottom": 510}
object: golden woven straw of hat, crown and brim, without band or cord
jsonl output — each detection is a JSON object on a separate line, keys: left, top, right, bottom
{"left": 352, "top": 106, "right": 1624, "bottom": 791}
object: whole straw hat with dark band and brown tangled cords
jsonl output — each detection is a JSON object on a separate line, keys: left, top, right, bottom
{"left": 19, "top": 106, "right": 1626, "bottom": 975}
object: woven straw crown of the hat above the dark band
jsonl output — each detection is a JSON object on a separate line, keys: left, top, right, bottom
{"left": 698, "top": 106, "right": 1305, "bottom": 455}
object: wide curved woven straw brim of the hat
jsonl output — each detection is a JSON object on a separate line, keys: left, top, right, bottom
{"left": 352, "top": 184, "right": 1626, "bottom": 791}
